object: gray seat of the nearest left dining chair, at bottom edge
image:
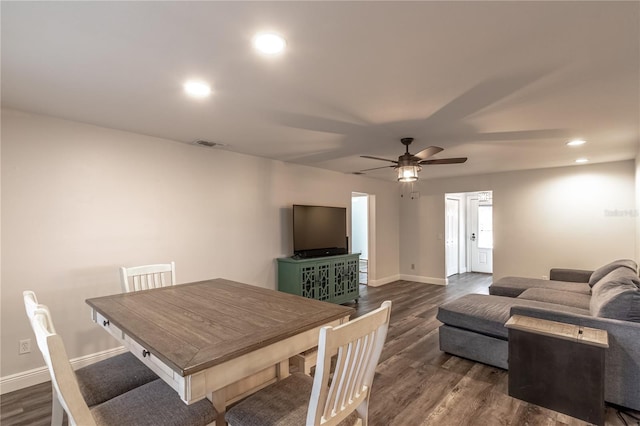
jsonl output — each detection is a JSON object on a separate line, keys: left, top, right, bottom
{"left": 91, "top": 379, "right": 216, "bottom": 426}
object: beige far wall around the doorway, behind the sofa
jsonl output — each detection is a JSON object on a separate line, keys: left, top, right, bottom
{"left": 400, "top": 161, "right": 636, "bottom": 282}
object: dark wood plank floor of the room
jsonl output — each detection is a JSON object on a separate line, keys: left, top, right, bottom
{"left": 0, "top": 273, "right": 640, "bottom": 426}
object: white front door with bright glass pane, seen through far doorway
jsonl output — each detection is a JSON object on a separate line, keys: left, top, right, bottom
{"left": 469, "top": 197, "right": 493, "bottom": 274}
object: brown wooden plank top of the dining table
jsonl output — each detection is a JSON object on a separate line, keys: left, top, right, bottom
{"left": 86, "top": 278, "right": 355, "bottom": 376}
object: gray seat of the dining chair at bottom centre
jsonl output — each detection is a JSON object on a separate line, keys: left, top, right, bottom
{"left": 225, "top": 373, "right": 358, "bottom": 426}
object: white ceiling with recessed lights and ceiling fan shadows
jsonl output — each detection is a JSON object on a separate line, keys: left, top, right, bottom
{"left": 1, "top": 1, "right": 640, "bottom": 180}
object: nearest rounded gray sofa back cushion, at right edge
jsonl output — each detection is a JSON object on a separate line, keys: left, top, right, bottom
{"left": 589, "top": 268, "right": 640, "bottom": 322}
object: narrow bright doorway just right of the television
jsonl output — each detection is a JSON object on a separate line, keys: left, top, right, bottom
{"left": 351, "top": 192, "right": 369, "bottom": 285}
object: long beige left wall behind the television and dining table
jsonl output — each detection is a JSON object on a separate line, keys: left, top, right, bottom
{"left": 0, "top": 110, "right": 399, "bottom": 377}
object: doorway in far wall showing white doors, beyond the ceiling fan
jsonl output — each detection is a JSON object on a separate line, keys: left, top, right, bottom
{"left": 444, "top": 191, "right": 493, "bottom": 277}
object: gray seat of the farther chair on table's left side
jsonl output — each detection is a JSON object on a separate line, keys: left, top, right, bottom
{"left": 76, "top": 352, "right": 158, "bottom": 407}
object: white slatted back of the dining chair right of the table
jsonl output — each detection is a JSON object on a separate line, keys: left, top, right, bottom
{"left": 307, "top": 301, "right": 391, "bottom": 426}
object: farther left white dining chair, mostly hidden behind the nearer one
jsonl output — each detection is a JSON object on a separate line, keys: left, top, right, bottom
{"left": 22, "top": 290, "right": 158, "bottom": 426}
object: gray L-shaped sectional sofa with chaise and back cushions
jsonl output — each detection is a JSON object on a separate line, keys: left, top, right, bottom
{"left": 437, "top": 259, "right": 640, "bottom": 410}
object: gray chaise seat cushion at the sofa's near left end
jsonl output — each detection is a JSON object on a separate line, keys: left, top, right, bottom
{"left": 436, "top": 294, "right": 589, "bottom": 339}
